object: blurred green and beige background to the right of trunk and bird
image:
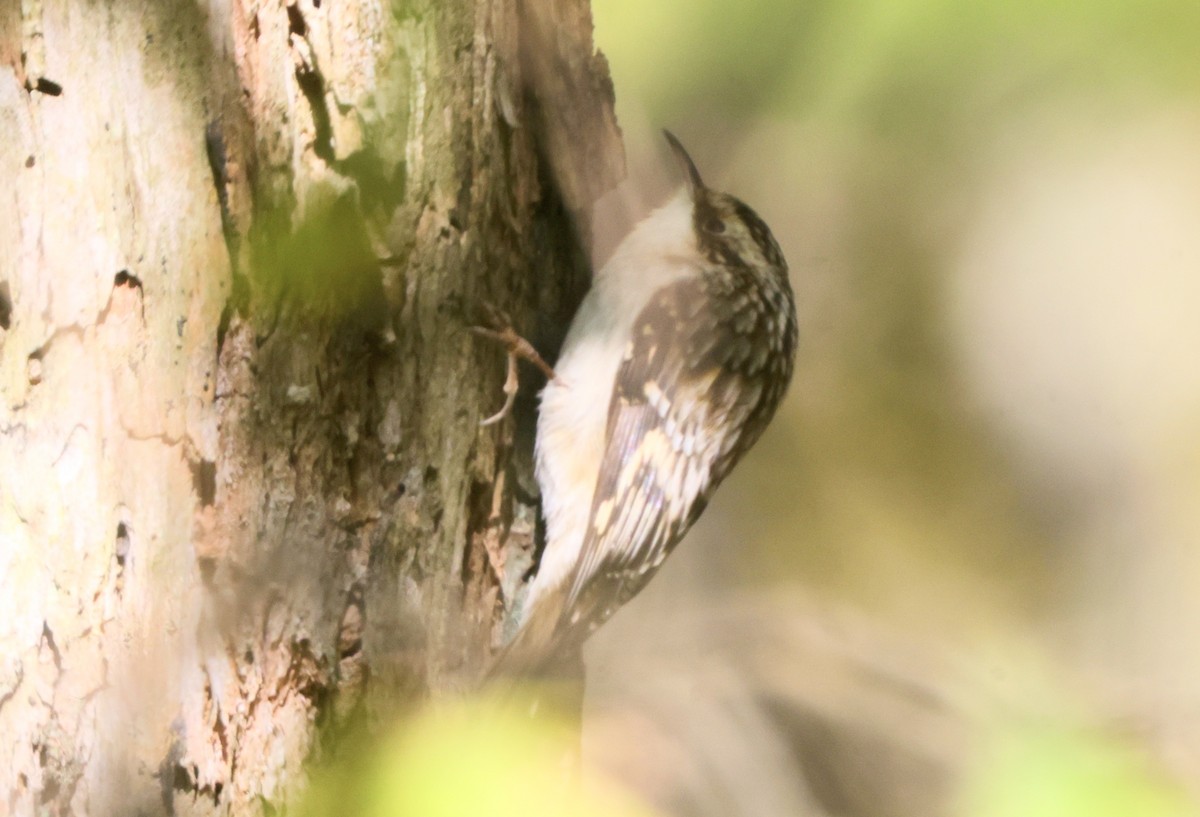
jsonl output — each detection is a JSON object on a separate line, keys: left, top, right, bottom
{"left": 573, "top": 0, "right": 1200, "bottom": 816}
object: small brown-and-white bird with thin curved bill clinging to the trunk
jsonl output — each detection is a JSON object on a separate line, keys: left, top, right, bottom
{"left": 487, "top": 133, "right": 797, "bottom": 672}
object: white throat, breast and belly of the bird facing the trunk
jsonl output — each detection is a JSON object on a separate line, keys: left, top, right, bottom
{"left": 526, "top": 192, "right": 700, "bottom": 617}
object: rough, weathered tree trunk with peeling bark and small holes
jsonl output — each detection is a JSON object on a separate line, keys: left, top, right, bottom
{"left": 0, "top": 0, "right": 623, "bottom": 815}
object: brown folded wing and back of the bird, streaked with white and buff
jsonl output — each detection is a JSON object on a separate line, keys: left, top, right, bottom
{"left": 559, "top": 268, "right": 796, "bottom": 643}
